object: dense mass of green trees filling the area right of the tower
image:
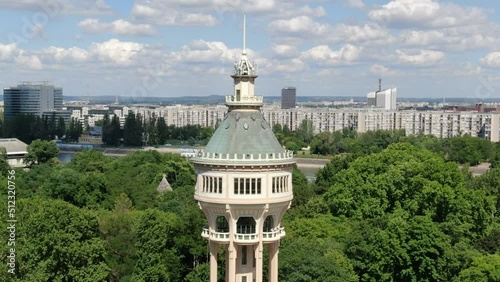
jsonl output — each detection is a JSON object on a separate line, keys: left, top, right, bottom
{"left": 281, "top": 143, "right": 500, "bottom": 281}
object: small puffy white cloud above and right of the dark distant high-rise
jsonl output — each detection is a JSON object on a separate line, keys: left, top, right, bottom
{"left": 300, "top": 44, "right": 362, "bottom": 65}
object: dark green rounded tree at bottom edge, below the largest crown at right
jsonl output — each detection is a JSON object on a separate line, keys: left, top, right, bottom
{"left": 345, "top": 213, "right": 450, "bottom": 281}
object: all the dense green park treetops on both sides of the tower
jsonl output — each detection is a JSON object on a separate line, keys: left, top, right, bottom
{"left": 0, "top": 134, "right": 500, "bottom": 282}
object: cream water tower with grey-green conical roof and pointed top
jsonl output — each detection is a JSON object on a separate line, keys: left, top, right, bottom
{"left": 192, "top": 15, "right": 295, "bottom": 282}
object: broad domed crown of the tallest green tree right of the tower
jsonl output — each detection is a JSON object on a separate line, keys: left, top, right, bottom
{"left": 325, "top": 143, "right": 465, "bottom": 221}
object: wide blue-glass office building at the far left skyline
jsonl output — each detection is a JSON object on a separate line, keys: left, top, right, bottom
{"left": 3, "top": 83, "right": 63, "bottom": 119}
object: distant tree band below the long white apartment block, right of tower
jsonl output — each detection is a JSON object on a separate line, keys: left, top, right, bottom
{"left": 286, "top": 126, "right": 500, "bottom": 166}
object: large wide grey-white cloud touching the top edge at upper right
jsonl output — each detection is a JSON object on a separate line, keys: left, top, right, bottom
{"left": 368, "top": 0, "right": 487, "bottom": 28}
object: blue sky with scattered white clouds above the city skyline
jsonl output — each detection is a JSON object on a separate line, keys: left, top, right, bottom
{"left": 0, "top": 0, "right": 500, "bottom": 101}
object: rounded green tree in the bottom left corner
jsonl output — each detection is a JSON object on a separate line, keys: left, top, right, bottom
{"left": 0, "top": 198, "right": 110, "bottom": 282}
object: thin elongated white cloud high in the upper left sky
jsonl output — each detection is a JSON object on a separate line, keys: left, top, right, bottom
{"left": 78, "top": 18, "right": 155, "bottom": 36}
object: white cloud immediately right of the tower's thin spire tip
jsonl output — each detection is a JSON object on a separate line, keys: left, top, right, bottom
{"left": 269, "top": 16, "right": 329, "bottom": 37}
